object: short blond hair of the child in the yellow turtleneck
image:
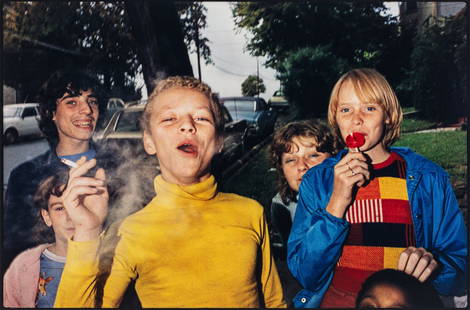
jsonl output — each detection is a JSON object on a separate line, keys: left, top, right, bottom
{"left": 141, "top": 76, "right": 225, "bottom": 136}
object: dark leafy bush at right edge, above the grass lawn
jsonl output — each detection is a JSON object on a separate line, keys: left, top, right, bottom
{"left": 407, "top": 7, "right": 468, "bottom": 122}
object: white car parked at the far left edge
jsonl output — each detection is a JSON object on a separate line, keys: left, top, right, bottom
{"left": 3, "top": 103, "right": 42, "bottom": 144}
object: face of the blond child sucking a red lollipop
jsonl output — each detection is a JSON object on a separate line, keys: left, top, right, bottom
{"left": 336, "top": 81, "right": 388, "bottom": 157}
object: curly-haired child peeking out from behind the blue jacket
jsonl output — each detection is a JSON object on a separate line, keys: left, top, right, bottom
{"left": 270, "top": 120, "right": 336, "bottom": 252}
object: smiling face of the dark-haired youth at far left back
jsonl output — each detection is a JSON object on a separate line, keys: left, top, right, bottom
{"left": 52, "top": 90, "right": 99, "bottom": 141}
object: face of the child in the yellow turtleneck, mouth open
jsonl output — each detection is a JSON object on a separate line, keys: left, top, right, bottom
{"left": 143, "top": 88, "right": 223, "bottom": 185}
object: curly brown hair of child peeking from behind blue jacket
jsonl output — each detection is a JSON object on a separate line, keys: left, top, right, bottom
{"left": 269, "top": 120, "right": 338, "bottom": 204}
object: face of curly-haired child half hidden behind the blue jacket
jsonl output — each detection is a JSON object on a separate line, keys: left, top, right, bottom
{"left": 281, "top": 137, "right": 330, "bottom": 192}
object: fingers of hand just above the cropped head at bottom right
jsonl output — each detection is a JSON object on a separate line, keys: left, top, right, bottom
{"left": 397, "top": 246, "right": 438, "bottom": 282}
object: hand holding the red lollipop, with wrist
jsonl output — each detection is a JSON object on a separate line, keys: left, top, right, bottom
{"left": 326, "top": 152, "right": 370, "bottom": 218}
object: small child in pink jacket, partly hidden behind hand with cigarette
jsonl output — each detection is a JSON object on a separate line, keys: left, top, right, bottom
{"left": 3, "top": 169, "right": 74, "bottom": 308}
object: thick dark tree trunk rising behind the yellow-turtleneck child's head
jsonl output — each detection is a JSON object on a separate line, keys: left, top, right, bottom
{"left": 125, "top": 0, "right": 193, "bottom": 94}
